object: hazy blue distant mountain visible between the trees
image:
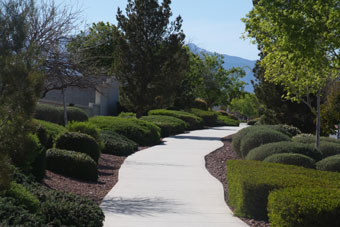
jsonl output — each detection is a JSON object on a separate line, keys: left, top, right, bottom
{"left": 188, "top": 43, "right": 256, "bottom": 92}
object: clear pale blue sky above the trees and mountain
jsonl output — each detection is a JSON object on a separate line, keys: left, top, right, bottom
{"left": 55, "top": 0, "right": 258, "bottom": 60}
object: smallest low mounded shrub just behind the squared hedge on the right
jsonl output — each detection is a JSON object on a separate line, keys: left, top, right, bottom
{"left": 263, "top": 153, "right": 315, "bottom": 168}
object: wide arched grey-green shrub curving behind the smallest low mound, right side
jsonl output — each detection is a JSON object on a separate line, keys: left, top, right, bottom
{"left": 245, "top": 141, "right": 322, "bottom": 161}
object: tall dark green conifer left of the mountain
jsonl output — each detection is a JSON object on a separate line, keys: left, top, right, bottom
{"left": 114, "top": 0, "right": 188, "bottom": 117}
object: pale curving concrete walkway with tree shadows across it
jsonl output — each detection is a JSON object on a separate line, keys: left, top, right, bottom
{"left": 101, "top": 126, "right": 248, "bottom": 227}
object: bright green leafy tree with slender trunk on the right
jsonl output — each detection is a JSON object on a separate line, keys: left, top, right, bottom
{"left": 244, "top": 0, "right": 340, "bottom": 147}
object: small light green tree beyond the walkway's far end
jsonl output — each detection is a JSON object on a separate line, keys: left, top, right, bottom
{"left": 230, "top": 93, "right": 260, "bottom": 118}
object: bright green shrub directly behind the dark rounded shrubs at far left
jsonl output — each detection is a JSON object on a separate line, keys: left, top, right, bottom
{"left": 34, "top": 120, "right": 67, "bottom": 149}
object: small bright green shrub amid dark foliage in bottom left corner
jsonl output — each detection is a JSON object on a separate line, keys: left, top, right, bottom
{"left": 6, "top": 181, "right": 39, "bottom": 213}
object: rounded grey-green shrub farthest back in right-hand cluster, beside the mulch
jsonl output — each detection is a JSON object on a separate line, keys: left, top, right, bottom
{"left": 240, "top": 127, "right": 291, "bottom": 158}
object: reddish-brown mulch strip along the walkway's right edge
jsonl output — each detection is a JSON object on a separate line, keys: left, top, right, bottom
{"left": 205, "top": 136, "right": 270, "bottom": 227}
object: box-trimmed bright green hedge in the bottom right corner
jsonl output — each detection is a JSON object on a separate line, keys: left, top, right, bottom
{"left": 268, "top": 187, "right": 340, "bottom": 227}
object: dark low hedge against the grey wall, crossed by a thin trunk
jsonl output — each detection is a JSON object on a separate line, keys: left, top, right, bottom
{"left": 34, "top": 104, "right": 88, "bottom": 125}
